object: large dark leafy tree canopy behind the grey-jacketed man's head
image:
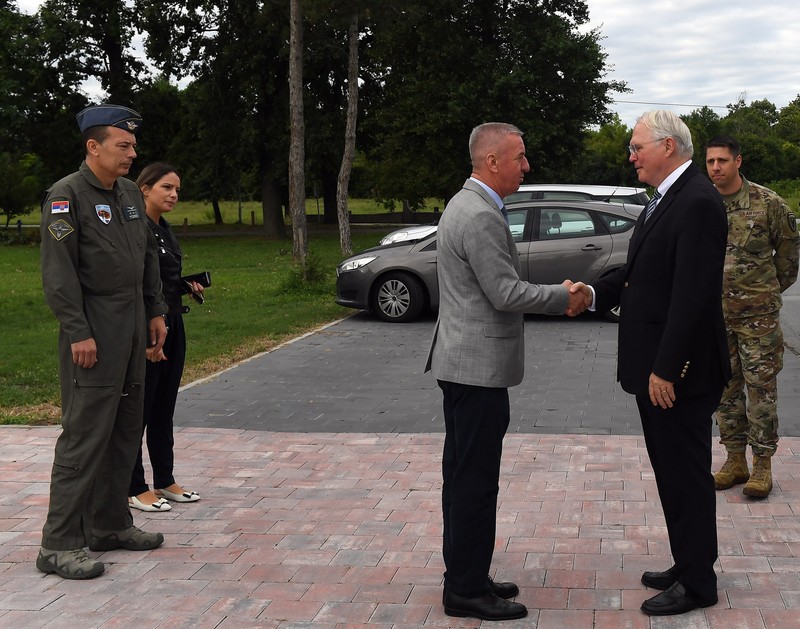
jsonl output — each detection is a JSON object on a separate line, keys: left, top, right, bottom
{"left": 366, "top": 0, "right": 625, "bottom": 204}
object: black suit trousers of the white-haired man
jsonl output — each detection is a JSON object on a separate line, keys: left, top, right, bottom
{"left": 636, "top": 389, "right": 722, "bottom": 600}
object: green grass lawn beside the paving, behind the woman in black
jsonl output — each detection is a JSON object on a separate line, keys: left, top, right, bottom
{"left": 0, "top": 227, "right": 389, "bottom": 423}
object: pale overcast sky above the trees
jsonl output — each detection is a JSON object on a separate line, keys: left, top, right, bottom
{"left": 19, "top": 0, "right": 800, "bottom": 127}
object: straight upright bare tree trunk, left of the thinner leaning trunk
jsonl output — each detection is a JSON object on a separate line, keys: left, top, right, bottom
{"left": 289, "top": 0, "right": 308, "bottom": 268}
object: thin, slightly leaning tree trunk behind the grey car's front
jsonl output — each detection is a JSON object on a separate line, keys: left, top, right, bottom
{"left": 336, "top": 11, "right": 358, "bottom": 256}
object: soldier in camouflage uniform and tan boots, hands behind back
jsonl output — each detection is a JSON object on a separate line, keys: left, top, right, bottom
{"left": 706, "top": 136, "right": 798, "bottom": 498}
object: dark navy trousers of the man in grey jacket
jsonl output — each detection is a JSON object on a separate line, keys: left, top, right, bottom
{"left": 438, "top": 380, "right": 509, "bottom": 597}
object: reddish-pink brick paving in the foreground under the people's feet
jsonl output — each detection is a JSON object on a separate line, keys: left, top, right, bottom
{"left": 0, "top": 427, "right": 800, "bottom": 629}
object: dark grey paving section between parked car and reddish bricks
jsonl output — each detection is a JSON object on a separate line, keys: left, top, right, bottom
{"left": 175, "top": 313, "right": 800, "bottom": 436}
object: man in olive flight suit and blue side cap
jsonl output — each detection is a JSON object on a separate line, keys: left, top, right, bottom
{"left": 36, "top": 105, "right": 167, "bottom": 579}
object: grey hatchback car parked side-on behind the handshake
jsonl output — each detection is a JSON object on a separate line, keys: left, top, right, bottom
{"left": 336, "top": 201, "right": 642, "bottom": 323}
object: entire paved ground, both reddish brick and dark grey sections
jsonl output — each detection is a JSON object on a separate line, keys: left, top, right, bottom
{"left": 0, "top": 316, "right": 800, "bottom": 629}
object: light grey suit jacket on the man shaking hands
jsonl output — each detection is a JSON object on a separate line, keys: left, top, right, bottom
{"left": 425, "top": 179, "right": 569, "bottom": 388}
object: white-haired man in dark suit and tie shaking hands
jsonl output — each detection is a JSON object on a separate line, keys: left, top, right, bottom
{"left": 571, "top": 111, "right": 730, "bottom": 615}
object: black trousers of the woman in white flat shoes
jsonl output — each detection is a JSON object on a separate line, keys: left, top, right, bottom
{"left": 128, "top": 315, "right": 186, "bottom": 496}
